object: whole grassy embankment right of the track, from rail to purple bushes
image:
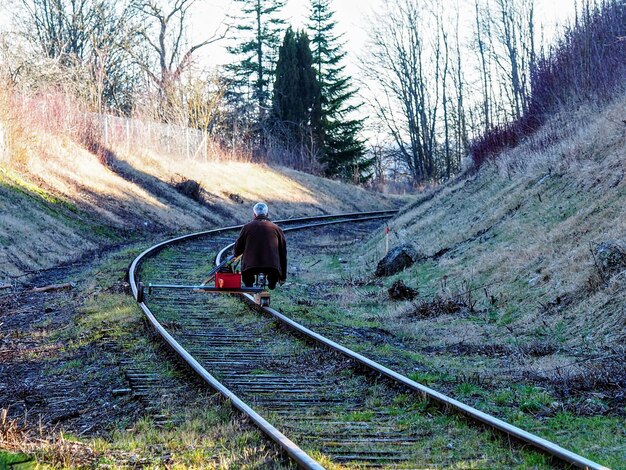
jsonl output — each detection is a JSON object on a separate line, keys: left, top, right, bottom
{"left": 275, "top": 96, "right": 626, "bottom": 468}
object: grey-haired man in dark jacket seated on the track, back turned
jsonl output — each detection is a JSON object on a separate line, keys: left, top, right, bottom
{"left": 233, "top": 202, "right": 287, "bottom": 289}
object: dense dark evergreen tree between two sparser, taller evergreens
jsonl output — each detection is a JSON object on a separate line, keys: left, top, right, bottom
{"left": 272, "top": 28, "right": 321, "bottom": 154}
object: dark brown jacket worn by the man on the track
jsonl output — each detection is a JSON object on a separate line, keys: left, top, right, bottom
{"left": 233, "top": 216, "right": 287, "bottom": 281}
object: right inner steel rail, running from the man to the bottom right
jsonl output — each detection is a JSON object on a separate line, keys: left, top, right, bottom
{"left": 215, "top": 229, "right": 610, "bottom": 470}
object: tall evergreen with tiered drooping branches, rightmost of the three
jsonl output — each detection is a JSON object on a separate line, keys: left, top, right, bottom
{"left": 309, "top": 0, "right": 373, "bottom": 181}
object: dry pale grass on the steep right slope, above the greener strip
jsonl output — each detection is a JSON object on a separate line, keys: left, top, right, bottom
{"left": 367, "top": 93, "right": 626, "bottom": 347}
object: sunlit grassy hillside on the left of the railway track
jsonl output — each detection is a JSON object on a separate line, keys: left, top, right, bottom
{"left": 0, "top": 127, "right": 399, "bottom": 281}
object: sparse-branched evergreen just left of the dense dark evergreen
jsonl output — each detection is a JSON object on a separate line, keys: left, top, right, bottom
{"left": 226, "top": 0, "right": 285, "bottom": 120}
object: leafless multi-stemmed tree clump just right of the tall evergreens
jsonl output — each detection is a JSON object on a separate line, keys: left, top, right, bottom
{"left": 363, "top": 0, "right": 467, "bottom": 183}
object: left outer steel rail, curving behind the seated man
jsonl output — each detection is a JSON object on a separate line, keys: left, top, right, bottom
{"left": 128, "top": 211, "right": 397, "bottom": 470}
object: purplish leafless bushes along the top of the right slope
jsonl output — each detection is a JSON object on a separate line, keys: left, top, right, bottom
{"left": 470, "top": 0, "right": 626, "bottom": 168}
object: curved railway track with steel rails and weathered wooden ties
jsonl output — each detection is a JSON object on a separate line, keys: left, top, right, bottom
{"left": 129, "top": 211, "right": 605, "bottom": 469}
